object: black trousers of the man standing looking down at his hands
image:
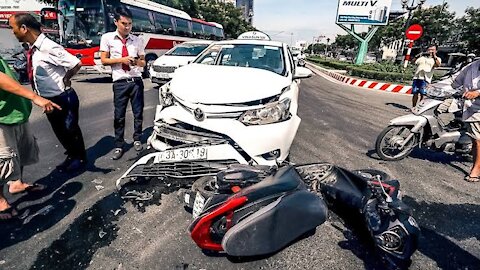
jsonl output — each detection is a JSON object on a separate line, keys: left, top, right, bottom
{"left": 113, "top": 77, "right": 144, "bottom": 148}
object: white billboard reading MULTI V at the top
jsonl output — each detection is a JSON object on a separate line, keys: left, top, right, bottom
{"left": 336, "top": 0, "right": 392, "bottom": 25}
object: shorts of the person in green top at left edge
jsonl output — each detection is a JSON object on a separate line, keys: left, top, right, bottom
{"left": 0, "top": 122, "right": 39, "bottom": 185}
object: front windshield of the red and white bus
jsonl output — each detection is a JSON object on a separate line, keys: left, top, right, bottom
{"left": 58, "top": 0, "right": 107, "bottom": 48}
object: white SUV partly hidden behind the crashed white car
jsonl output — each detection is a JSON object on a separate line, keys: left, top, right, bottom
{"left": 149, "top": 40, "right": 212, "bottom": 85}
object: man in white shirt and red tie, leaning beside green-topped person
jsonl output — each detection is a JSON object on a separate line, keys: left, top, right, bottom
{"left": 9, "top": 14, "right": 87, "bottom": 172}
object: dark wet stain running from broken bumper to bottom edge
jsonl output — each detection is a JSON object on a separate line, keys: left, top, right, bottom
{"left": 30, "top": 176, "right": 193, "bottom": 270}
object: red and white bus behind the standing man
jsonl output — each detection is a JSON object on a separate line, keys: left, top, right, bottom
{"left": 52, "top": 0, "right": 224, "bottom": 77}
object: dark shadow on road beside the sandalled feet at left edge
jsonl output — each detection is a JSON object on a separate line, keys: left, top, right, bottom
{"left": 0, "top": 182, "right": 83, "bottom": 250}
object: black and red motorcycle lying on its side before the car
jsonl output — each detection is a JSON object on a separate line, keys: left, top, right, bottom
{"left": 185, "top": 163, "right": 420, "bottom": 269}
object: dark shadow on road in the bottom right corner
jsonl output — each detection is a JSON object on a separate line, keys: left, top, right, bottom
{"left": 403, "top": 196, "right": 480, "bottom": 269}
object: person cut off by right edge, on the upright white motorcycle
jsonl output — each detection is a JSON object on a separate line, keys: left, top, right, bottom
{"left": 452, "top": 60, "right": 480, "bottom": 182}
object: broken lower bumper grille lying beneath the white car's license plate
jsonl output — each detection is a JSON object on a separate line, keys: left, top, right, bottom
{"left": 126, "top": 158, "right": 238, "bottom": 178}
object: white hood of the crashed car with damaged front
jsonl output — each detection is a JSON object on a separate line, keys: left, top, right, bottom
{"left": 170, "top": 64, "right": 291, "bottom": 104}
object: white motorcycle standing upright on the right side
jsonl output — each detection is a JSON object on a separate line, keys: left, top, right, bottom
{"left": 375, "top": 77, "right": 472, "bottom": 161}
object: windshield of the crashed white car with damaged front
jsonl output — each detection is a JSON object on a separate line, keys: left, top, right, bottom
{"left": 195, "top": 44, "right": 286, "bottom": 75}
